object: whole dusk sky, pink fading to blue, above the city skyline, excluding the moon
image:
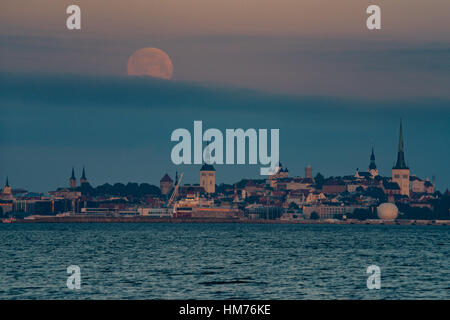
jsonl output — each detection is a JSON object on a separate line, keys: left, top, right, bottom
{"left": 0, "top": 0, "right": 450, "bottom": 191}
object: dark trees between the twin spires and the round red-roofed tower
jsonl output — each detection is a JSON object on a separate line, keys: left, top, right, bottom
{"left": 76, "top": 182, "right": 161, "bottom": 198}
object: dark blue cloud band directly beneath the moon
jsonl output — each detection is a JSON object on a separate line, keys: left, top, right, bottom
{"left": 0, "top": 72, "right": 449, "bottom": 113}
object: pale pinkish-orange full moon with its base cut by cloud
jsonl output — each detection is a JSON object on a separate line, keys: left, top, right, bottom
{"left": 127, "top": 48, "right": 173, "bottom": 80}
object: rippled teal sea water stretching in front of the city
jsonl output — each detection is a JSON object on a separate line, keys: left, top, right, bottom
{"left": 0, "top": 223, "right": 450, "bottom": 299}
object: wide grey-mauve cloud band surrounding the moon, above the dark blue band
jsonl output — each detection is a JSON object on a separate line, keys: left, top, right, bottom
{"left": 0, "top": 34, "right": 450, "bottom": 99}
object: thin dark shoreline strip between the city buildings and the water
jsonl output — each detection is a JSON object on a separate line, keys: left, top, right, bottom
{"left": 3, "top": 216, "right": 450, "bottom": 226}
